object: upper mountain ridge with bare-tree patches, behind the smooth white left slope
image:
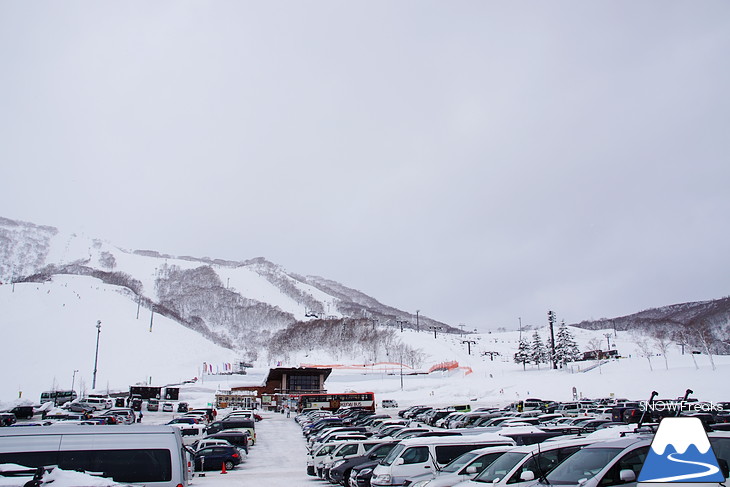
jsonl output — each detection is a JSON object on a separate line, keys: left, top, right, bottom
{"left": 0, "top": 218, "right": 458, "bottom": 349}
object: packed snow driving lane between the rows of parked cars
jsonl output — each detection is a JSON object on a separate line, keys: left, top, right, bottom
{"left": 182, "top": 413, "right": 322, "bottom": 487}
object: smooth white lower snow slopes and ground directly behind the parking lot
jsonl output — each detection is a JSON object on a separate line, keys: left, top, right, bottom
{"left": 0, "top": 276, "right": 730, "bottom": 412}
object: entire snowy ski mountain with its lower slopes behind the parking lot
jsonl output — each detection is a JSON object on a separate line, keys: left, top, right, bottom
{"left": 0, "top": 215, "right": 730, "bottom": 405}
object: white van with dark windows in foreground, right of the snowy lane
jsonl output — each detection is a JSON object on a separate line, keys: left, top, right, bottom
{"left": 370, "top": 433, "right": 515, "bottom": 487}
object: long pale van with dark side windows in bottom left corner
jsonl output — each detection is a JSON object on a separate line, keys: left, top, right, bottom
{"left": 0, "top": 425, "right": 191, "bottom": 487}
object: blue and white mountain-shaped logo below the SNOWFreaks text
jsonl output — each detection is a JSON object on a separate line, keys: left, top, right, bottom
{"left": 639, "top": 417, "right": 725, "bottom": 482}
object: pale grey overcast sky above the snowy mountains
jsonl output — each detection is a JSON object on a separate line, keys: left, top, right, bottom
{"left": 0, "top": 0, "right": 730, "bottom": 329}
